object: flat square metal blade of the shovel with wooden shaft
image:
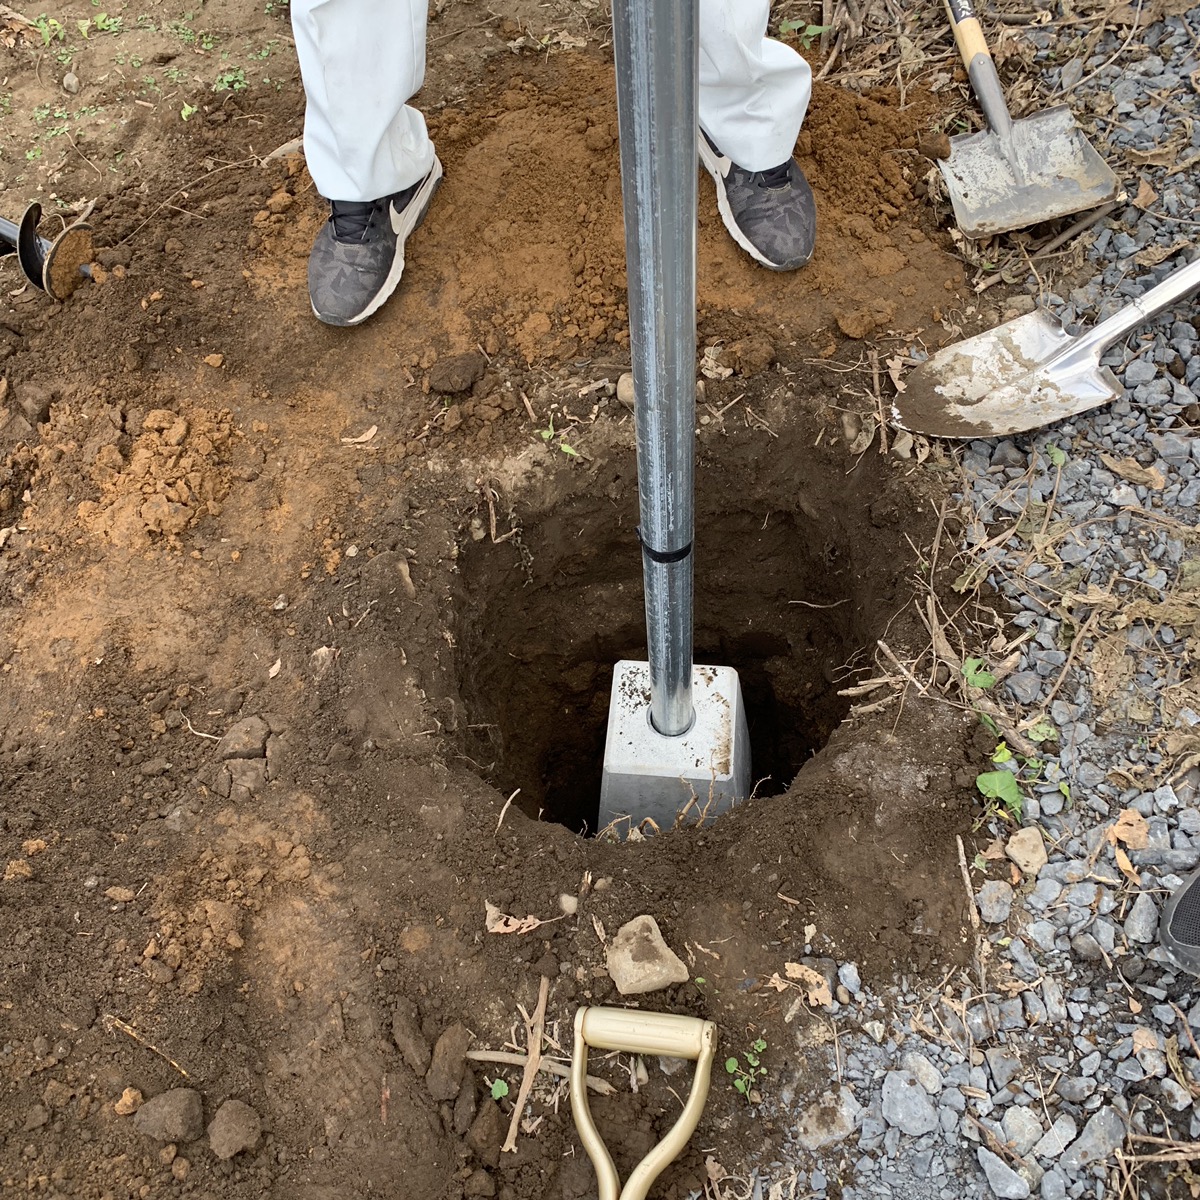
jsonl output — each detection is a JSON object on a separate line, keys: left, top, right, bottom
{"left": 938, "top": 104, "right": 1120, "bottom": 238}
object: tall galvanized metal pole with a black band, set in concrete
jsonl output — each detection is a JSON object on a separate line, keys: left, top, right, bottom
{"left": 613, "top": 0, "right": 698, "bottom": 737}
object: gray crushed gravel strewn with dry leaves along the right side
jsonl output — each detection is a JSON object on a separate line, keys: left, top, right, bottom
{"left": 730, "top": 7, "right": 1200, "bottom": 1200}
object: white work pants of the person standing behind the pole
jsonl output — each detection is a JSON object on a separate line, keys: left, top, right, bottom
{"left": 292, "top": 0, "right": 812, "bottom": 200}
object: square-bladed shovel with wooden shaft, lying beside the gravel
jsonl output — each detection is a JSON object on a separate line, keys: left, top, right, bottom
{"left": 938, "top": 0, "right": 1120, "bottom": 238}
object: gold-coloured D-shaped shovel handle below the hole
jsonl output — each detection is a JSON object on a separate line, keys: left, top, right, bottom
{"left": 571, "top": 1008, "right": 716, "bottom": 1200}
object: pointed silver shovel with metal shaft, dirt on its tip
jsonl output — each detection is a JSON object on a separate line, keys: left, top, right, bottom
{"left": 892, "top": 258, "right": 1200, "bottom": 438}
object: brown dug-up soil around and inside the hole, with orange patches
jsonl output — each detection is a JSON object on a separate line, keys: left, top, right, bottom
{"left": 0, "top": 6, "right": 993, "bottom": 1200}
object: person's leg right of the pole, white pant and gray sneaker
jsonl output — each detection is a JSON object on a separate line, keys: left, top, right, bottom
{"left": 700, "top": 0, "right": 816, "bottom": 271}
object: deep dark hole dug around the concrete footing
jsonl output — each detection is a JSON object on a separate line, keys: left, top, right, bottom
{"left": 456, "top": 448, "right": 904, "bottom": 834}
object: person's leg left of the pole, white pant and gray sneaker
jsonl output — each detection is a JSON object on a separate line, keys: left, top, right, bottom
{"left": 292, "top": 0, "right": 442, "bottom": 325}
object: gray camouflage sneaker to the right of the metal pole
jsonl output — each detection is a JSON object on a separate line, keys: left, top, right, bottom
{"left": 700, "top": 131, "right": 817, "bottom": 271}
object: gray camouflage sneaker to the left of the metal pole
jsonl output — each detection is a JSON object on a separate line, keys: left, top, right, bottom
{"left": 308, "top": 158, "right": 442, "bottom": 325}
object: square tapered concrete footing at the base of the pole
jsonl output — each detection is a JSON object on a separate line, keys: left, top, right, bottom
{"left": 599, "top": 659, "right": 750, "bottom": 832}
